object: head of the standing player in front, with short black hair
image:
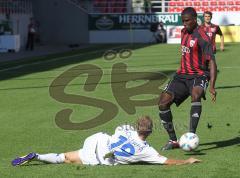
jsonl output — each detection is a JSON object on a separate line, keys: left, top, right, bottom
{"left": 181, "top": 7, "right": 197, "bottom": 32}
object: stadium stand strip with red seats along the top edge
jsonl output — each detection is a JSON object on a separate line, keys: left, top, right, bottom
{"left": 69, "top": 0, "right": 240, "bottom": 13}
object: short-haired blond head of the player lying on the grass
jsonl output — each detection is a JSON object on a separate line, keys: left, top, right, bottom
{"left": 137, "top": 116, "right": 153, "bottom": 138}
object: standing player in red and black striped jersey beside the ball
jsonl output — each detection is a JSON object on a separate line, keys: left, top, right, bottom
{"left": 158, "top": 7, "right": 217, "bottom": 150}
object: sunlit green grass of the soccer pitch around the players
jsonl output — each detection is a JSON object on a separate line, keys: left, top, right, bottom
{"left": 0, "top": 44, "right": 240, "bottom": 177}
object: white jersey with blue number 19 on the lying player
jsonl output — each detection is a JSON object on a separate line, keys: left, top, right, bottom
{"left": 110, "top": 125, "right": 167, "bottom": 164}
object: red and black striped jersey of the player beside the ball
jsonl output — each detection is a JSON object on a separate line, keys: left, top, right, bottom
{"left": 177, "top": 26, "right": 215, "bottom": 77}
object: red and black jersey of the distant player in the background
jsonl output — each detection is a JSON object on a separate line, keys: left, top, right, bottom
{"left": 202, "top": 23, "right": 222, "bottom": 53}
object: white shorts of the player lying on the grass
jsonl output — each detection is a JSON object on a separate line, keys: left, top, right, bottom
{"left": 79, "top": 132, "right": 111, "bottom": 165}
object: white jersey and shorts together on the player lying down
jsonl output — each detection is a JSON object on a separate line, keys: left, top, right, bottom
{"left": 79, "top": 125, "right": 167, "bottom": 165}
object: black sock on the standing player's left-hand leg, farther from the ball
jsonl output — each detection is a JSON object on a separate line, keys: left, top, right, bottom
{"left": 159, "top": 109, "right": 177, "bottom": 141}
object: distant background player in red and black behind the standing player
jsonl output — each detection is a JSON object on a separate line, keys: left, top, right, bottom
{"left": 202, "top": 11, "right": 224, "bottom": 53}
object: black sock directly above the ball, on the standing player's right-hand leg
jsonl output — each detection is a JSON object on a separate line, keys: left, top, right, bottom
{"left": 189, "top": 102, "right": 202, "bottom": 133}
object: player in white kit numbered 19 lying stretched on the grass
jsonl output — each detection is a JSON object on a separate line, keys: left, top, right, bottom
{"left": 12, "top": 116, "right": 200, "bottom": 166}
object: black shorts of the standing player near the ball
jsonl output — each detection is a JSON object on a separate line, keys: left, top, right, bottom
{"left": 163, "top": 75, "right": 208, "bottom": 106}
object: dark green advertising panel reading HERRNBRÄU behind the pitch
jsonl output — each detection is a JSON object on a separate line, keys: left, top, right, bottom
{"left": 88, "top": 13, "right": 203, "bottom": 30}
